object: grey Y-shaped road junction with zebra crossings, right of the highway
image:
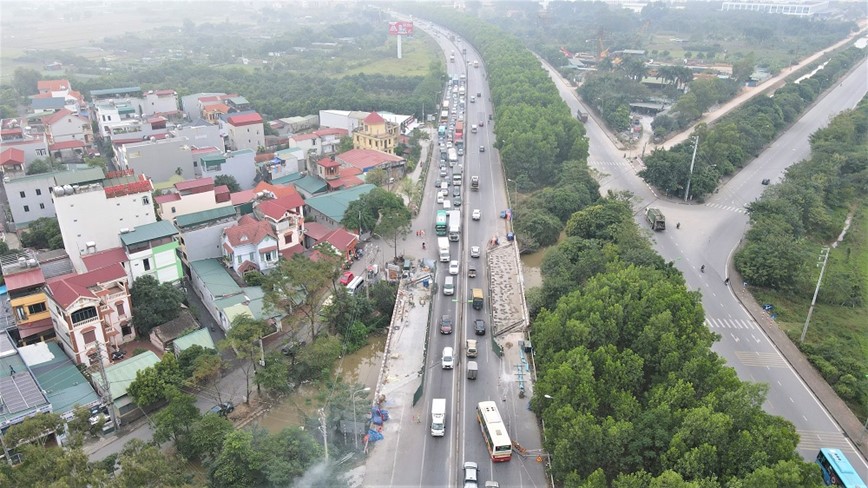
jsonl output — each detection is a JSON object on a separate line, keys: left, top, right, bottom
{"left": 553, "top": 53, "right": 868, "bottom": 479}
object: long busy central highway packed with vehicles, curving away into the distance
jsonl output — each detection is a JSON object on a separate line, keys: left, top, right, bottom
{"left": 393, "top": 23, "right": 546, "bottom": 487}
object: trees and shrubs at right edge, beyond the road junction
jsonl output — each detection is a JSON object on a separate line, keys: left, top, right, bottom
{"left": 735, "top": 98, "right": 868, "bottom": 417}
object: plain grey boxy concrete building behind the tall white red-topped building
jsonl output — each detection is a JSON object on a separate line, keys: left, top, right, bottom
{"left": 115, "top": 138, "right": 195, "bottom": 184}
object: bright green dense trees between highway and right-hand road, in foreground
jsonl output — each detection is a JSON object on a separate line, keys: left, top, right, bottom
{"left": 531, "top": 197, "right": 822, "bottom": 488}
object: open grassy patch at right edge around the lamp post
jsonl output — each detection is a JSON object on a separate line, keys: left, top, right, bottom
{"left": 753, "top": 203, "right": 868, "bottom": 419}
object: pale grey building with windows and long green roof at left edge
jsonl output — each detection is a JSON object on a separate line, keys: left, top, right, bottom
{"left": 4, "top": 168, "right": 105, "bottom": 227}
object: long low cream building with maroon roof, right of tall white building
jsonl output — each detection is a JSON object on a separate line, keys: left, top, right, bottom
{"left": 154, "top": 176, "right": 232, "bottom": 221}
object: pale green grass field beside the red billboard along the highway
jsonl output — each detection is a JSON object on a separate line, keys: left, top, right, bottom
{"left": 334, "top": 35, "right": 444, "bottom": 77}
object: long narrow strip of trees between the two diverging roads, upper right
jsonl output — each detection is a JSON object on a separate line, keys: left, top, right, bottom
{"left": 639, "top": 48, "right": 865, "bottom": 199}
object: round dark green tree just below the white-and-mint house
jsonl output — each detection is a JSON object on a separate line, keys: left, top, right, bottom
{"left": 130, "top": 275, "right": 184, "bottom": 337}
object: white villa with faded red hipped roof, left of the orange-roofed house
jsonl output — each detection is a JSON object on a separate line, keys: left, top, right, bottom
{"left": 223, "top": 215, "right": 278, "bottom": 276}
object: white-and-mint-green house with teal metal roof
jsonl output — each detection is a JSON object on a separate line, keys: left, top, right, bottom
{"left": 120, "top": 220, "right": 183, "bottom": 283}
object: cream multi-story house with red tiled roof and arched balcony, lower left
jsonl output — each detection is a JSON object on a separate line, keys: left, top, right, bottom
{"left": 45, "top": 263, "right": 135, "bottom": 366}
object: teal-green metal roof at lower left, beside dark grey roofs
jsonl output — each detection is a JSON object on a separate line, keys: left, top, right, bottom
{"left": 27, "top": 342, "right": 99, "bottom": 415}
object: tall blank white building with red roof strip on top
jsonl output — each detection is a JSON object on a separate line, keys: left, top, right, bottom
{"left": 52, "top": 171, "right": 156, "bottom": 271}
